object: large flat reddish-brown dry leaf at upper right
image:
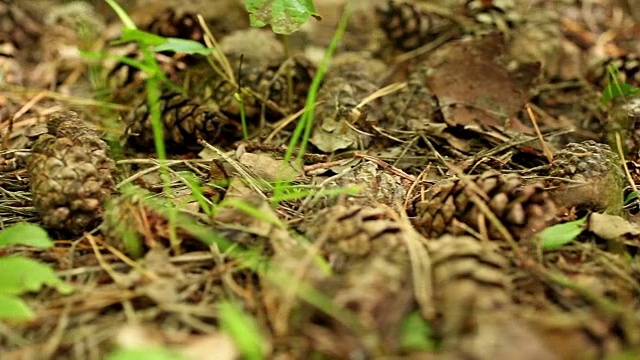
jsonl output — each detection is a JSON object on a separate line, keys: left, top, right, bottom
{"left": 427, "top": 33, "right": 540, "bottom": 126}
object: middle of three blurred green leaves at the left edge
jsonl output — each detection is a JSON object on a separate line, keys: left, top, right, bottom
{"left": 0, "top": 256, "right": 73, "bottom": 295}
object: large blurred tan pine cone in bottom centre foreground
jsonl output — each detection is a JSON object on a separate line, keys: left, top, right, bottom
{"left": 303, "top": 205, "right": 416, "bottom": 352}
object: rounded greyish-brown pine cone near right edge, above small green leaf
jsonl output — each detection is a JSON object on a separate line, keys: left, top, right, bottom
{"left": 547, "top": 140, "right": 624, "bottom": 211}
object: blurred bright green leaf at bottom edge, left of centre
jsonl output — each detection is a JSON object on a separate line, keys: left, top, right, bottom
{"left": 219, "top": 302, "right": 264, "bottom": 360}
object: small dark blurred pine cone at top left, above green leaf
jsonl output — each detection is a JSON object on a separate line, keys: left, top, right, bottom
{"left": 147, "top": 8, "right": 204, "bottom": 41}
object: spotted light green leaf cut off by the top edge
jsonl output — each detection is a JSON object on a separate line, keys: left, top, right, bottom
{"left": 244, "top": 0, "right": 318, "bottom": 35}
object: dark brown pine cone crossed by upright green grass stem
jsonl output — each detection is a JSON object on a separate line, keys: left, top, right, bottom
{"left": 126, "top": 92, "right": 241, "bottom": 152}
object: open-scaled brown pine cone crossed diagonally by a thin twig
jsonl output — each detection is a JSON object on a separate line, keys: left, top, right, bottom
{"left": 414, "top": 171, "right": 555, "bottom": 239}
